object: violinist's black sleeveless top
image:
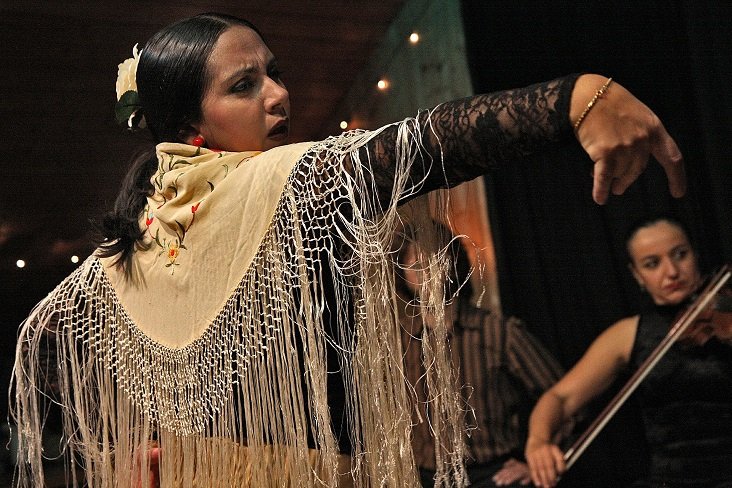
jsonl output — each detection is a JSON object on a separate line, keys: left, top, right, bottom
{"left": 631, "top": 307, "right": 732, "bottom": 488}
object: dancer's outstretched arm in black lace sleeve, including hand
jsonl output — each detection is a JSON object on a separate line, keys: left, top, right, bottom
{"left": 370, "top": 74, "right": 685, "bottom": 203}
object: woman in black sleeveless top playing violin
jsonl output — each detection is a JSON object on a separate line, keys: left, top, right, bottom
{"left": 526, "top": 216, "right": 732, "bottom": 488}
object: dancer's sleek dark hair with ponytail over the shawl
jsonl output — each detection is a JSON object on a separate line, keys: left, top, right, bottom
{"left": 94, "top": 13, "right": 264, "bottom": 269}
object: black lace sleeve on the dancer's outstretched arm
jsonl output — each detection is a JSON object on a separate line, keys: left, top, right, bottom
{"left": 368, "top": 74, "right": 579, "bottom": 202}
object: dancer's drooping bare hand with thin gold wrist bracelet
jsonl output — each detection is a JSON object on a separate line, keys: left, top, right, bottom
{"left": 570, "top": 75, "right": 686, "bottom": 204}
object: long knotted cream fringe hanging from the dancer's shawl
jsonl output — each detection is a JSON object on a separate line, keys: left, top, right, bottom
{"left": 12, "top": 113, "right": 465, "bottom": 488}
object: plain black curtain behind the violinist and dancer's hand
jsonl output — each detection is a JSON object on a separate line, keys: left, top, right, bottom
{"left": 462, "top": 0, "right": 732, "bottom": 487}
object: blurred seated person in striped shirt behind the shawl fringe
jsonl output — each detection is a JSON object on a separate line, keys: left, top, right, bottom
{"left": 397, "top": 223, "right": 563, "bottom": 487}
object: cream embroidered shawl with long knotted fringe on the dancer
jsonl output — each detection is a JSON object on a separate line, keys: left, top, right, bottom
{"left": 13, "top": 120, "right": 464, "bottom": 487}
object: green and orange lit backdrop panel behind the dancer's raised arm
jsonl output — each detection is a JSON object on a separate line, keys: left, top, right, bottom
{"left": 324, "top": 0, "right": 501, "bottom": 312}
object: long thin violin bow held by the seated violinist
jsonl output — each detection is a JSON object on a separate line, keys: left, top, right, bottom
{"left": 564, "top": 264, "right": 732, "bottom": 469}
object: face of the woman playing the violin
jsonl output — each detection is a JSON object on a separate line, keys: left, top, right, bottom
{"left": 628, "top": 220, "right": 701, "bottom": 305}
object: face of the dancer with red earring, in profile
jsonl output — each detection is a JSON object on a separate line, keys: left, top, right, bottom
{"left": 193, "top": 26, "right": 290, "bottom": 151}
